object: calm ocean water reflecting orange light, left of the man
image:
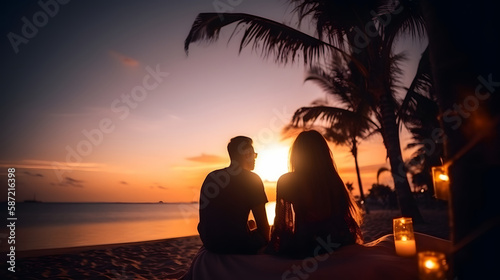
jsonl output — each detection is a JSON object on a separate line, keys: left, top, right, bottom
{"left": 0, "top": 203, "right": 198, "bottom": 251}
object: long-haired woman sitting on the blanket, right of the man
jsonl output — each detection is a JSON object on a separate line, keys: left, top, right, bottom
{"left": 268, "top": 130, "right": 363, "bottom": 258}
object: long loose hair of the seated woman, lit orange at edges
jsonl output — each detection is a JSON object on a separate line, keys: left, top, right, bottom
{"left": 290, "top": 130, "right": 362, "bottom": 242}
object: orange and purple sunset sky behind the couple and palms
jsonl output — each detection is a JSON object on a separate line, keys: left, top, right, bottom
{"left": 0, "top": 0, "right": 425, "bottom": 202}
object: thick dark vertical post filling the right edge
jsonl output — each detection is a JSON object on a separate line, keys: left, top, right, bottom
{"left": 421, "top": 0, "right": 500, "bottom": 279}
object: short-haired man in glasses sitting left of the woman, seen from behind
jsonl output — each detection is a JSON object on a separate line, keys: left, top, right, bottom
{"left": 198, "top": 136, "right": 269, "bottom": 254}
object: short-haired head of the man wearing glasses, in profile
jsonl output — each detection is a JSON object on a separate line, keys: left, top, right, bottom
{"left": 227, "top": 136, "right": 257, "bottom": 170}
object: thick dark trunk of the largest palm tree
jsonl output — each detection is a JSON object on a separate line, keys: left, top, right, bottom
{"left": 380, "top": 93, "right": 423, "bottom": 223}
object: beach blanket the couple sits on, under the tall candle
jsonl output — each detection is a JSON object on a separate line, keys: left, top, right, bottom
{"left": 181, "top": 233, "right": 450, "bottom": 280}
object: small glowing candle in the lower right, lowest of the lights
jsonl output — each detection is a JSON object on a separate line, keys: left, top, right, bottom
{"left": 418, "top": 251, "right": 448, "bottom": 280}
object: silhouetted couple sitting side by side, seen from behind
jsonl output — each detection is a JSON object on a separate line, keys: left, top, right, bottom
{"left": 198, "top": 130, "right": 362, "bottom": 258}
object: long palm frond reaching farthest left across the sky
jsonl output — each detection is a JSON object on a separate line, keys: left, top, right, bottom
{"left": 184, "top": 13, "right": 349, "bottom": 64}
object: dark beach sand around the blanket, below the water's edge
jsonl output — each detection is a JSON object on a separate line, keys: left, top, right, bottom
{"left": 0, "top": 209, "right": 449, "bottom": 279}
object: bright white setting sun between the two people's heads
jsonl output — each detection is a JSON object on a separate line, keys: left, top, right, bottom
{"left": 255, "top": 146, "right": 289, "bottom": 182}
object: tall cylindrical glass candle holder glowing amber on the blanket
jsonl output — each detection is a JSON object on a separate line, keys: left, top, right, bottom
{"left": 392, "top": 217, "right": 417, "bottom": 257}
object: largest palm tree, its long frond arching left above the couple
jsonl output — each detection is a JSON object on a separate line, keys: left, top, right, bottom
{"left": 185, "top": 0, "right": 424, "bottom": 222}
